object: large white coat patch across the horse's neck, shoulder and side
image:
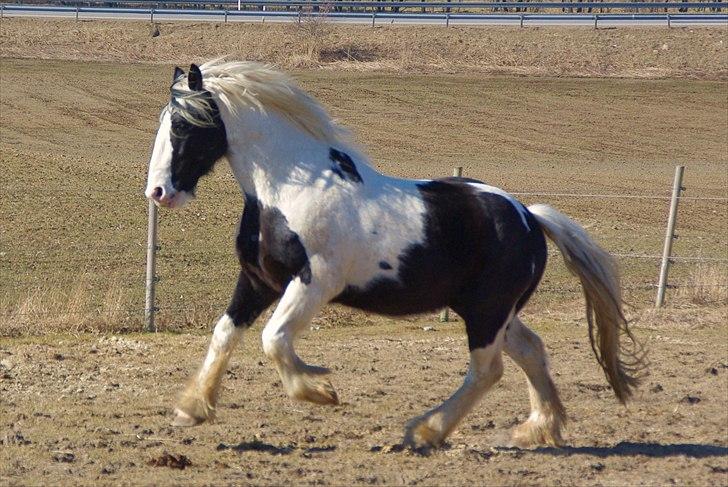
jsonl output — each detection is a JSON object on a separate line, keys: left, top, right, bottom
{"left": 221, "top": 109, "right": 425, "bottom": 299}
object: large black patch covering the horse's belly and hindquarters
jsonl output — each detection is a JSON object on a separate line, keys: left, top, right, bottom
{"left": 334, "top": 178, "right": 546, "bottom": 350}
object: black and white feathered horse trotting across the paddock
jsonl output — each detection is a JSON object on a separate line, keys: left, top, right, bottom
{"left": 145, "top": 60, "right": 643, "bottom": 448}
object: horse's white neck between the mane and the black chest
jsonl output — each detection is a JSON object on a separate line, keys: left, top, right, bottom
{"left": 226, "top": 108, "right": 342, "bottom": 205}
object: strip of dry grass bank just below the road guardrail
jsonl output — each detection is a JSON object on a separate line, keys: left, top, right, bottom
{"left": 0, "top": 16, "right": 728, "bottom": 79}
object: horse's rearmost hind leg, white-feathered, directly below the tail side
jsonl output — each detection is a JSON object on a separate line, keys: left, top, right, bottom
{"left": 504, "top": 317, "right": 566, "bottom": 447}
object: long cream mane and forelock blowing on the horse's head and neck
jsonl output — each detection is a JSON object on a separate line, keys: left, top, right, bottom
{"left": 171, "top": 59, "right": 351, "bottom": 145}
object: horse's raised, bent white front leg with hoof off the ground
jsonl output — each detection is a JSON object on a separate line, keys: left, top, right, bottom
{"left": 263, "top": 277, "right": 339, "bottom": 404}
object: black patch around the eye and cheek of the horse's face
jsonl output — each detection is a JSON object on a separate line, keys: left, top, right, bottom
{"left": 170, "top": 91, "right": 228, "bottom": 194}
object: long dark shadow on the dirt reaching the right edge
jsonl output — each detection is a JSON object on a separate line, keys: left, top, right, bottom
{"left": 520, "top": 441, "right": 728, "bottom": 458}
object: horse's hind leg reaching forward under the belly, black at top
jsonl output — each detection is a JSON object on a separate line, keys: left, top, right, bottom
{"left": 404, "top": 311, "right": 510, "bottom": 447}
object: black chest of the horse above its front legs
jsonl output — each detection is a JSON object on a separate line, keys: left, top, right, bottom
{"left": 236, "top": 195, "right": 311, "bottom": 291}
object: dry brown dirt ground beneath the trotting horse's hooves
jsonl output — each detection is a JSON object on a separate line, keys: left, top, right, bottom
{"left": 0, "top": 316, "right": 728, "bottom": 486}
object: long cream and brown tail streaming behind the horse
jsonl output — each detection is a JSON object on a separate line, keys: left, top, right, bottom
{"left": 528, "top": 204, "right": 644, "bottom": 403}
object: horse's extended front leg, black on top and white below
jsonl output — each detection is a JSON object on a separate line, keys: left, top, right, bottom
{"left": 172, "top": 271, "right": 279, "bottom": 426}
